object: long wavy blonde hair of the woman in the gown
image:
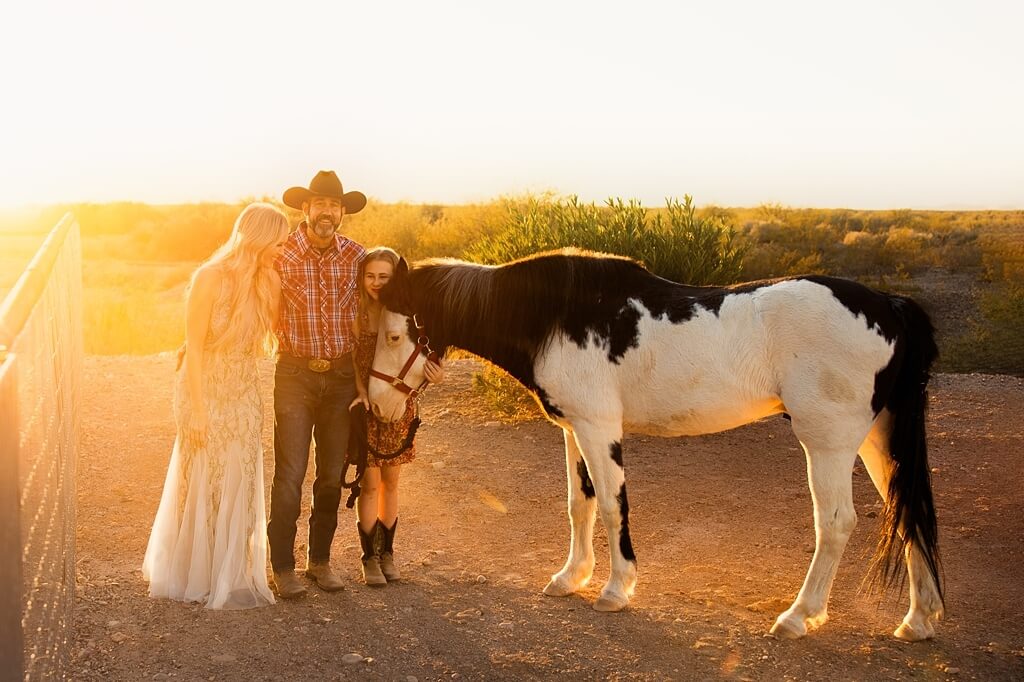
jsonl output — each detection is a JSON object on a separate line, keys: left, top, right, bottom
{"left": 189, "top": 202, "right": 288, "bottom": 354}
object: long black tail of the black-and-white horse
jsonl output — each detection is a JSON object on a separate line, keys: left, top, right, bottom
{"left": 872, "top": 295, "right": 942, "bottom": 599}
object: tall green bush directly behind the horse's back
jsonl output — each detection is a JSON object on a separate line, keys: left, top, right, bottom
{"left": 466, "top": 196, "right": 745, "bottom": 285}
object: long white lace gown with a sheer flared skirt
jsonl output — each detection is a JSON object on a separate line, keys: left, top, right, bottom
{"left": 142, "top": 278, "right": 273, "bottom": 608}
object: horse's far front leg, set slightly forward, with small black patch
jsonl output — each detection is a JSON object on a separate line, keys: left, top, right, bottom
{"left": 544, "top": 429, "right": 597, "bottom": 597}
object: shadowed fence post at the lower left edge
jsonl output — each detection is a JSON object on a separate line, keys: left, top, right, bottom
{"left": 0, "top": 346, "right": 25, "bottom": 680}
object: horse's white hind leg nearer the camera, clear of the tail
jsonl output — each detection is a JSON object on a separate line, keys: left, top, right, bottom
{"left": 771, "top": 417, "right": 869, "bottom": 638}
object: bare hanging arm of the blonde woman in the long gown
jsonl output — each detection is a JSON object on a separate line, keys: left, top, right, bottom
{"left": 183, "top": 269, "right": 221, "bottom": 447}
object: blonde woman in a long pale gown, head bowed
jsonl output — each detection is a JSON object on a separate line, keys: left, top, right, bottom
{"left": 142, "top": 203, "right": 288, "bottom": 608}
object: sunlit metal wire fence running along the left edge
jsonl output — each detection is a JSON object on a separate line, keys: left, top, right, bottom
{"left": 0, "top": 214, "right": 83, "bottom": 680}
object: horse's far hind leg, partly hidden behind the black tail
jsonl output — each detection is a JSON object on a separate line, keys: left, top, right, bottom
{"left": 860, "top": 410, "right": 942, "bottom": 641}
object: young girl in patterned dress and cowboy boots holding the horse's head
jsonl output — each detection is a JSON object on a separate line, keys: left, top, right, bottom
{"left": 352, "top": 247, "right": 444, "bottom": 587}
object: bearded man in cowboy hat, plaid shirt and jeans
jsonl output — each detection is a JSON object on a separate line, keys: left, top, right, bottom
{"left": 267, "top": 171, "right": 367, "bottom": 599}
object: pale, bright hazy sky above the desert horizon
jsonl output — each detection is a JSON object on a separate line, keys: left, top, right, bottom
{"left": 0, "top": 0, "right": 1024, "bottom": 209}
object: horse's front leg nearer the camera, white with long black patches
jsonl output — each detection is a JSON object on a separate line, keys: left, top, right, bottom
{"left": 573, "top": 421, "right": 637, "bottom": 611}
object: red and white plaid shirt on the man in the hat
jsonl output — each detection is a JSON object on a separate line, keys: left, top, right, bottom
{"left": 274, "top": 221, "right": 366, "bottom": 359}
